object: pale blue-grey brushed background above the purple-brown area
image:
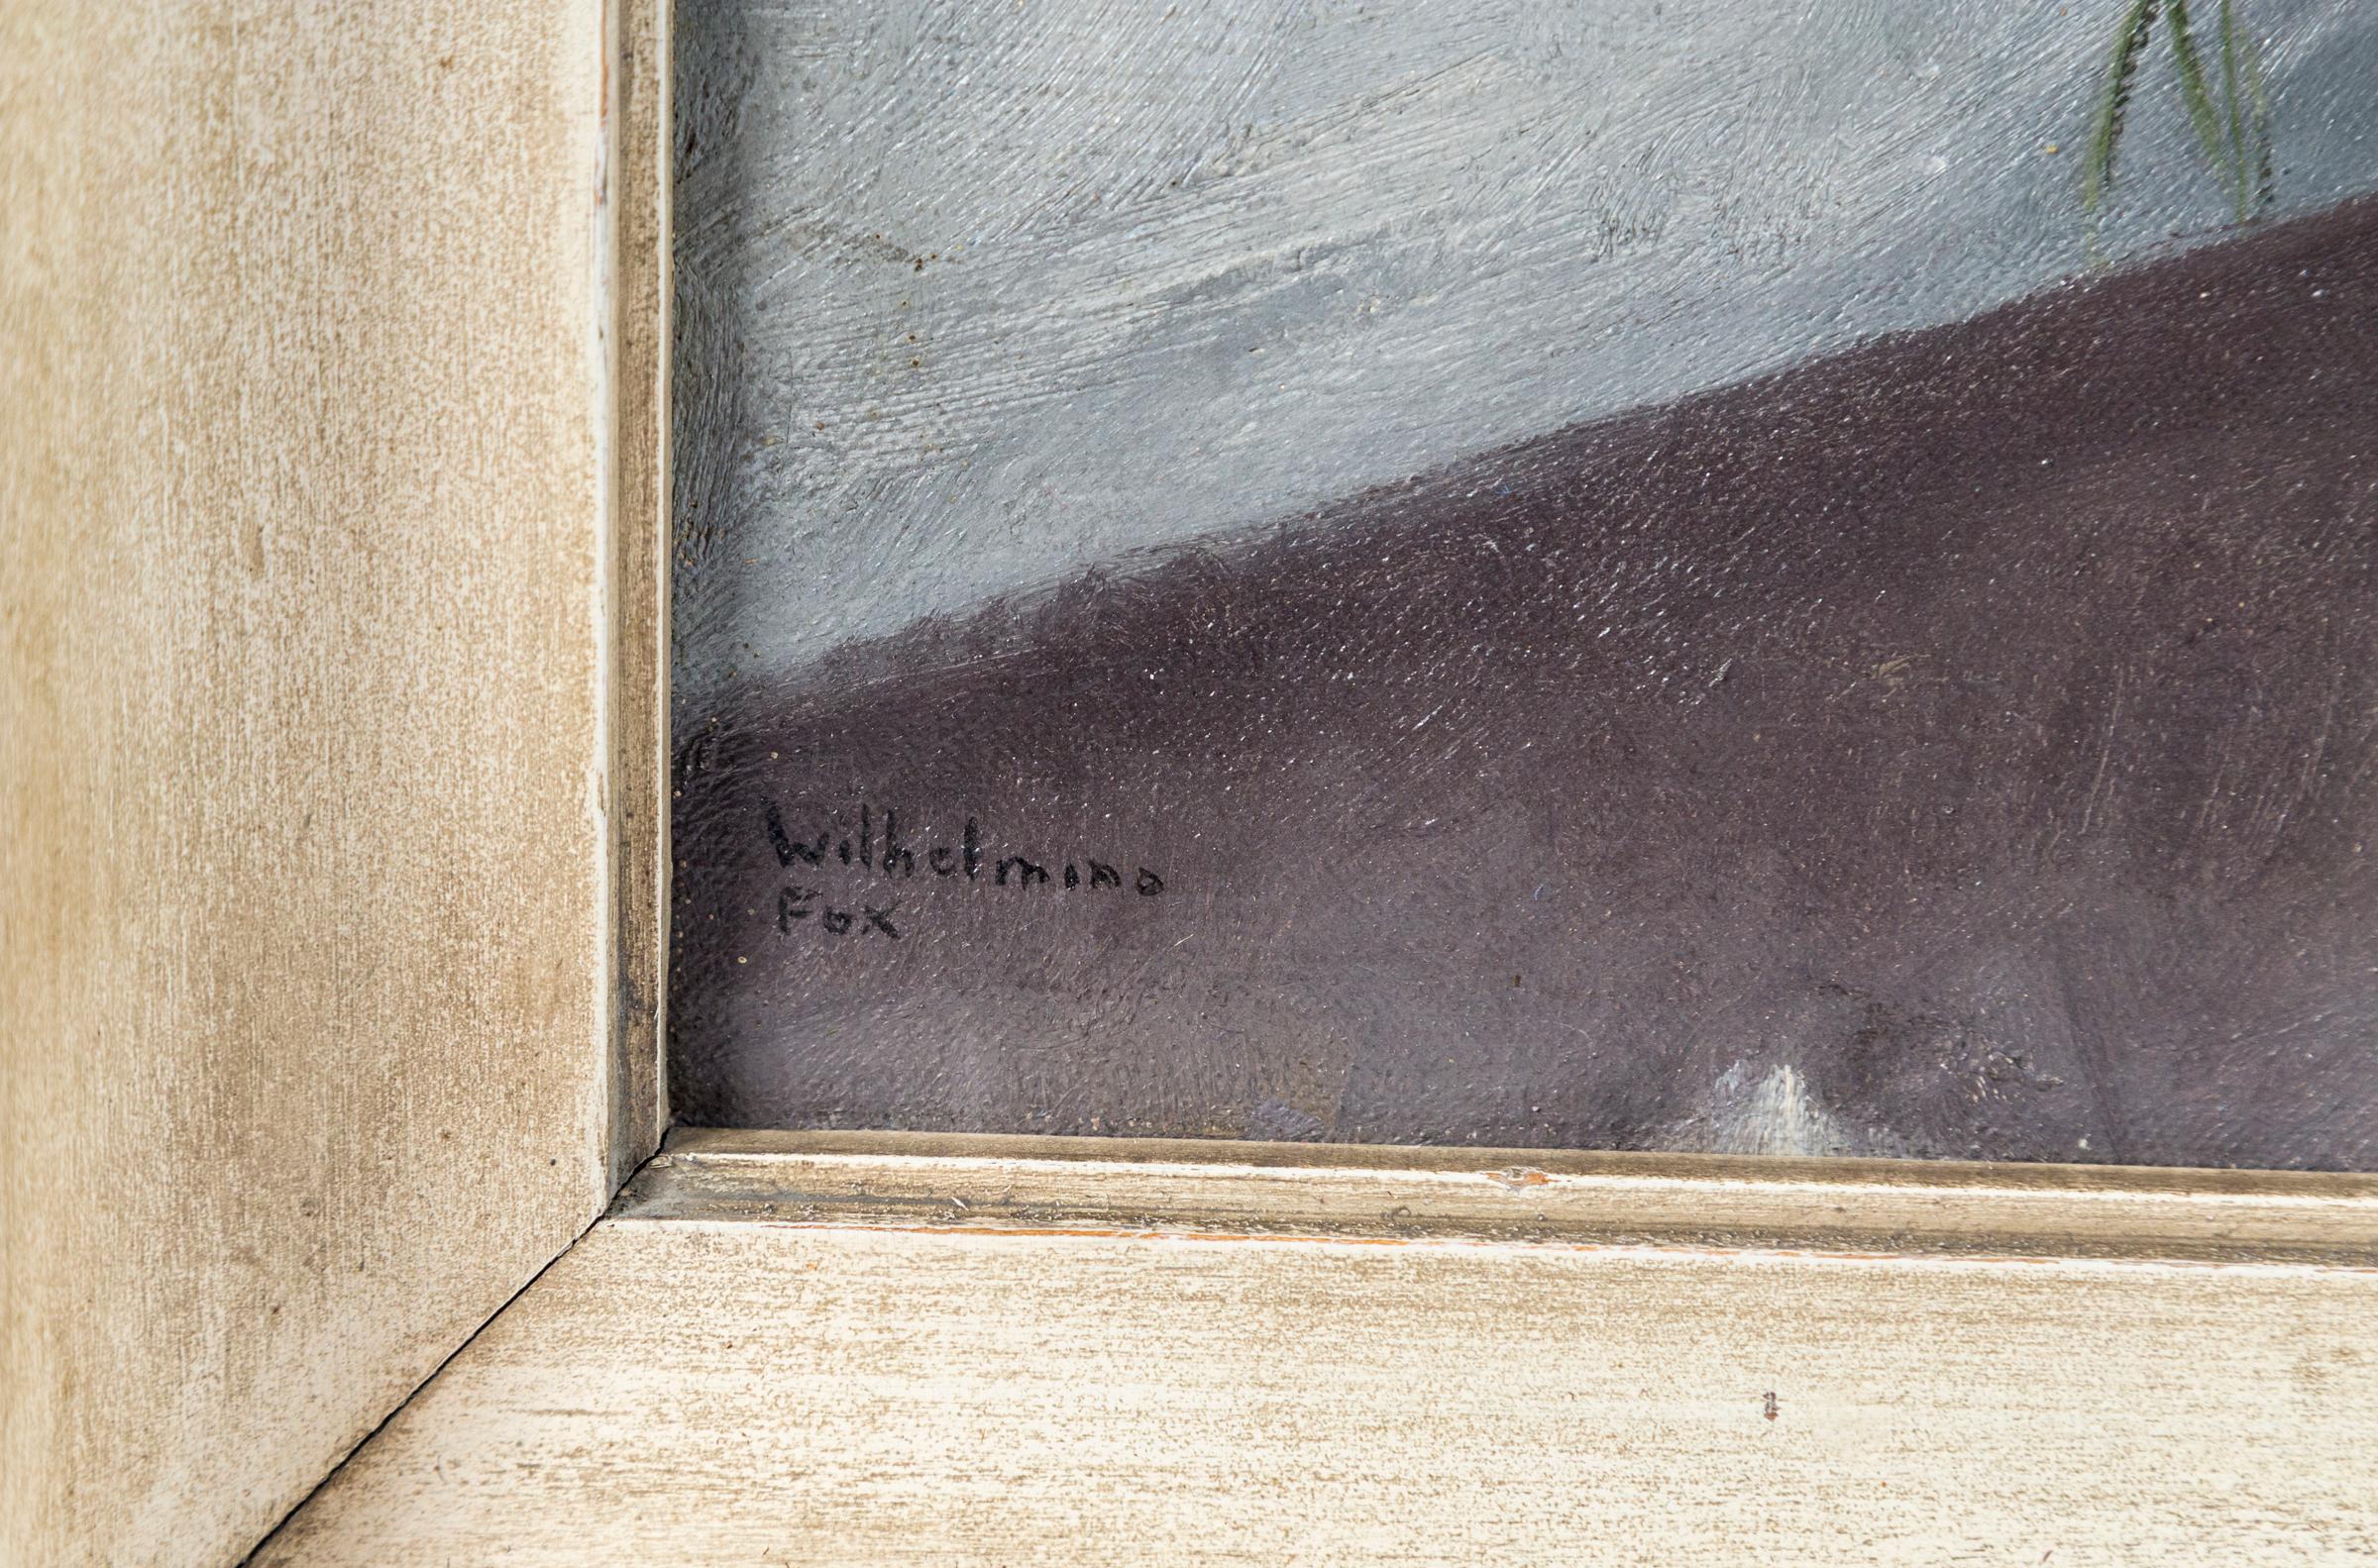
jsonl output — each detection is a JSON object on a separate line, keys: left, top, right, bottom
{"left": 676, "top": 0, "right": 2378, "bottom": 702}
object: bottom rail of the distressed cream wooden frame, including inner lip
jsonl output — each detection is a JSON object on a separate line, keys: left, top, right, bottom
{"left": 260, "top": 1140, "right": 2378, "bottom": 1568}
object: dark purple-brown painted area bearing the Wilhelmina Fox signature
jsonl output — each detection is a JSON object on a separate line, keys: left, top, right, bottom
{"left": 671, "top": 202, "right": 2378, "bottom": 1169}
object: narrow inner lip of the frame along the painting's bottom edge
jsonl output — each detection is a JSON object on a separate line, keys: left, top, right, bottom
{"left": 611, "top": 1128, "right": 2378, "bottom": 1266}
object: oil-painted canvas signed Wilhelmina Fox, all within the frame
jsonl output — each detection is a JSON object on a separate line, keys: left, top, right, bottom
{"left": 671, "top": 0, "right": 2378, "bottom": 1169}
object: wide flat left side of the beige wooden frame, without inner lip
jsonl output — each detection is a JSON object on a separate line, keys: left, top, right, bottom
{"left": 0, "top": 0, "right": 642, "bottom": 1563}
